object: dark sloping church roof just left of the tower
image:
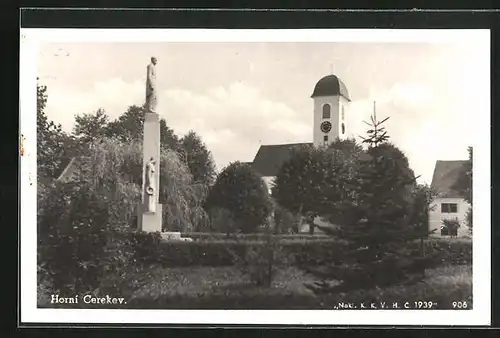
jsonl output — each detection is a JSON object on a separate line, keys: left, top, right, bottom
{"left": 252, "top": 143, "right": 312, "bottom": 176}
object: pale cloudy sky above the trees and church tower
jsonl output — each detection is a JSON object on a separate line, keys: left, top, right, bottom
{"left": 37, "top": 39, "right": 490, "bottom": 183}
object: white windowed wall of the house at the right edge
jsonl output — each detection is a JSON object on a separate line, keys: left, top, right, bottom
{"left": 429, "top": 198, "right": 470, "bottom": 237}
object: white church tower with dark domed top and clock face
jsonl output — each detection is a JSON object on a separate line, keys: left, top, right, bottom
{"left": 311, "top": 75, "right": 351, "bottom": 146}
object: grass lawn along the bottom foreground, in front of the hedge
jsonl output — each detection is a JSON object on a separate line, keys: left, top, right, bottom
{"left": 39, "top": 265, "right": 472, "bottom": 310}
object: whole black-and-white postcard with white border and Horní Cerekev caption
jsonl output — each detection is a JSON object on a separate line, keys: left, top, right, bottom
{"left": 20, "top": 29, "right": 491, "bottom": 325}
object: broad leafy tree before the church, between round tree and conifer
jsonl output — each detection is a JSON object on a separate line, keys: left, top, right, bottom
{"left": 273, "top": 139, "right": 363, "bottom": 232}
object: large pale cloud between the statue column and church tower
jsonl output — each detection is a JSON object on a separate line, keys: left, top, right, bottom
{"left": 162, "top": 82, "right": 312, "bottom": 168}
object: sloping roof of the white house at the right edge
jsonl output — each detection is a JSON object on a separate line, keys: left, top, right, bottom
{"left": 431, "top": 161, "right": 467, "bottom": 198}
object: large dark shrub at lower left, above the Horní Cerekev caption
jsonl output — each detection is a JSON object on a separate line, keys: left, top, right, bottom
{"left": 38, "top": 183, "right": 137, "bottom": 293}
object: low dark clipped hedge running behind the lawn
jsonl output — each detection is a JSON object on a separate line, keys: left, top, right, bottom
{"left": 134, "top": 233, "right": 472, "bottom": 267}
